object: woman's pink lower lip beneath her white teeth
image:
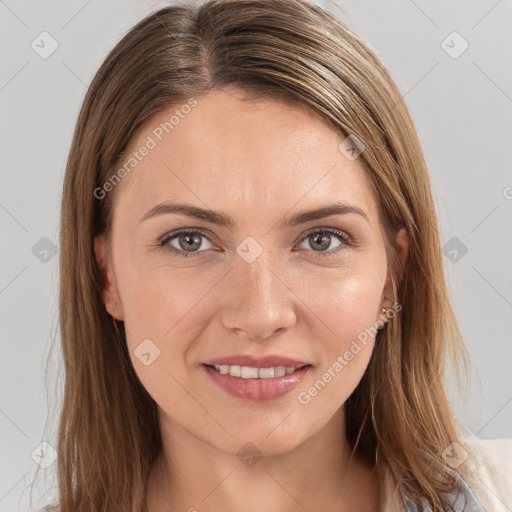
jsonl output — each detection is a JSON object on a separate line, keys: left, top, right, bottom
{"left": 203, "top": 365, "right": 311, "bottom": 401}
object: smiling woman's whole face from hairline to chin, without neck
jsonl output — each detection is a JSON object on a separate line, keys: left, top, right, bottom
{"left": 95, "top": 90, "right": 404, "bottom": 453}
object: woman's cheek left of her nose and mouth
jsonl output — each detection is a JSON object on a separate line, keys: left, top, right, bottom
{"left": 118, "top": 265, "right": 219, "bottom": 414}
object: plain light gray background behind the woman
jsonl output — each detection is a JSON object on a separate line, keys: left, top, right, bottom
{"left": 0, "top": 0, "right": 512, "bottom": 512}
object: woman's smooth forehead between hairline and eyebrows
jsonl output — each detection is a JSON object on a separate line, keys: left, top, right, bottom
{"left": 116, "top": 90, "right": 377, "bottom": 226}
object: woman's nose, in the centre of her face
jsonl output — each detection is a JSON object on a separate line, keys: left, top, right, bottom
{"left": 220, "top": 255, "right": 297, "bottom": 341}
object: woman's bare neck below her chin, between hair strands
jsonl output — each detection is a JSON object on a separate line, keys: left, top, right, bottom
{"left": 147, "top": 407, "right": 380, "bottom": 512}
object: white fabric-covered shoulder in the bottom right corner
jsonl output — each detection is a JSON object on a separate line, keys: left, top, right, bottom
{"left": 463, "top": 437, "right": 512, "bottom": 512}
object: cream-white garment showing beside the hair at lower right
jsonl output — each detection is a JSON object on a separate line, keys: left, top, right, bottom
{"left": 380, "top": 438, "right": 512, "bottom": 512}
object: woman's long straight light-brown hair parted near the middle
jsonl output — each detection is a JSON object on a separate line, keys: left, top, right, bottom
{"left": 45, "top": 0, "right": 468, "bottom": 512}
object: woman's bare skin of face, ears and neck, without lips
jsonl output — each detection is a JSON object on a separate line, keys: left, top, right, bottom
{"left": 95, "top": 89, "right": 408, "bottom": 512}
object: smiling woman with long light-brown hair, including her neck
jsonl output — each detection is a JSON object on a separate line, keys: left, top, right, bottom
{"left": 46, "top": 0, "right": 511, "bottom": 512}
